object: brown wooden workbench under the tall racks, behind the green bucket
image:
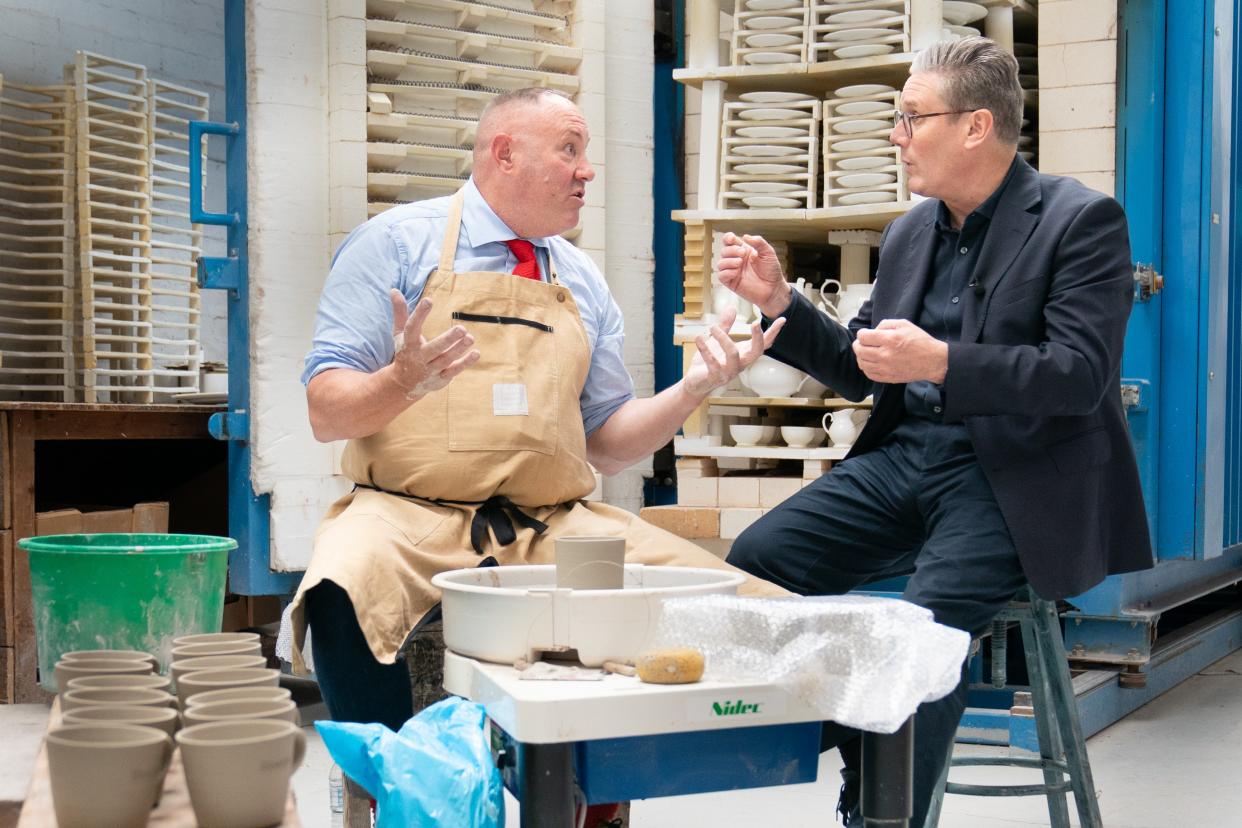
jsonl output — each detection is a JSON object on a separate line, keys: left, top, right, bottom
{"left": 0, "top": 402, "right": 227, "bottom": 703}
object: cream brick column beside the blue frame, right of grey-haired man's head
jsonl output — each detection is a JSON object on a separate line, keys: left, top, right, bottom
{"left": 1038, "top": 0, "right": 1118, "bottom": 195}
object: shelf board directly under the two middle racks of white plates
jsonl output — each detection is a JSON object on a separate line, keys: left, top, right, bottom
{"left": 673, "top": 201, "right": 918, "bottom": 238}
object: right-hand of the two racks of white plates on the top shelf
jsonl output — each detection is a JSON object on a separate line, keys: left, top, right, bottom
{"left": 810, "top": 0, "right": 910, "bottom": 61}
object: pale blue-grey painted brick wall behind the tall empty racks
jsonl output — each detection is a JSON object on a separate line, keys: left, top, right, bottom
{"left": 0, "top": 0, "right": 229, "bottom": 361}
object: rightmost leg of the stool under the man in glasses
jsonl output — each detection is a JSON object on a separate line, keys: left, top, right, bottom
{"left": 1031, "top": 592, "right": 1103, "bottom": 828}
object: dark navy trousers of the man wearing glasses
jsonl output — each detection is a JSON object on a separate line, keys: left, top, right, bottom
{"left": 728, "top": 417, "right": 1026, "bottom": 826}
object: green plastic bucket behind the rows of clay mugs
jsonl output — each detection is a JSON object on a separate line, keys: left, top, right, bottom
{"left": 17, "top": 534, "right": 237, "bottom": 693}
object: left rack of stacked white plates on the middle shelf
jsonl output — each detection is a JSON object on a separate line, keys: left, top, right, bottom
{"left": 719, "top": 91, "right": 820, "bottom": 210}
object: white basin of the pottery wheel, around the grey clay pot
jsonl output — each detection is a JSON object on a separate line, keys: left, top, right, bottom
{"left": 431, "top": 564, "right": 744, "bottom": 667}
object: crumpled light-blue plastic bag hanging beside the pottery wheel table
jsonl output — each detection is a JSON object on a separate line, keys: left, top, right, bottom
{"left": 314, "top": 696, "right": 504, "bottom": 828}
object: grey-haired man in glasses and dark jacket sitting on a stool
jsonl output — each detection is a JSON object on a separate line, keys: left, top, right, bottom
{"left": 718, "top": 37, "right": 1151, "bottom": 826}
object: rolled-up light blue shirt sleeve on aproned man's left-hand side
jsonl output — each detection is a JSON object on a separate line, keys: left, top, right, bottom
{"left": 302, "top": 222, "right": 406, "bottom": 384}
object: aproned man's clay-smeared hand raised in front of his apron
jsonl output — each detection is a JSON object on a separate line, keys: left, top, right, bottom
{"left": 389, "top": 289, "right": 478, "bottom": 400}
